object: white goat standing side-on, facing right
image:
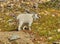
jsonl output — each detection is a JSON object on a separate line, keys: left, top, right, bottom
{"left": 17, "top": 13, "right": 39, "bottom": 30}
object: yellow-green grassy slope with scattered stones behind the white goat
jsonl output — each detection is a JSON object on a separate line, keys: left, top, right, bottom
{"left": 0, "top": 0, "right": 60, "bottom": 43}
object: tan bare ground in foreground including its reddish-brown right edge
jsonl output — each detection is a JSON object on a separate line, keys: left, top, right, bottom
{"left": 0, "top": 31, "right": 47, "bottom": 44}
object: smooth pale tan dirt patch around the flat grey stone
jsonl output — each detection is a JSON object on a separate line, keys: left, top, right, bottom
{"left": 0, "top": 31, "right": 34, "bottom": 44}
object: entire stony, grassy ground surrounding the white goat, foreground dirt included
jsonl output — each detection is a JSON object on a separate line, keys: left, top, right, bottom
{"left": 0, "top": 0, "right": 60, "bottom": 44}
